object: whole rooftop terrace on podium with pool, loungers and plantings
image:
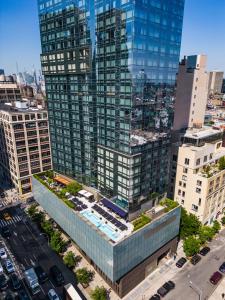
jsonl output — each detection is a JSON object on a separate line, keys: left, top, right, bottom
{"left": 34, "top": 171, "right": 178, "bottom": 243}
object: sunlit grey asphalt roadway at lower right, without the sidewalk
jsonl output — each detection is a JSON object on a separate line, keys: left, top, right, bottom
{"left": 164, "top": 230, "right": 225, "bottom": 300}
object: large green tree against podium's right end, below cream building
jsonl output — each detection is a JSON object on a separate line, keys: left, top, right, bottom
{"left": 180, "top": 207, "right": 201, "bottom": 239}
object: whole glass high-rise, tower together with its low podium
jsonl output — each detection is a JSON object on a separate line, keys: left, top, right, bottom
{"left": 36, "top": 0, "right": 184, "bottom": 297}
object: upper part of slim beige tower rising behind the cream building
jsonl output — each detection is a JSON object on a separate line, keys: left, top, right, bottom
{"left": 173, "top": 55, "right": 208, "bottom": 131}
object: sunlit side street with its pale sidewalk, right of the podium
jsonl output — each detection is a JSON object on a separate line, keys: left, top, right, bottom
{"left": 124, "top": 229, "right": 225, "bottom": 300}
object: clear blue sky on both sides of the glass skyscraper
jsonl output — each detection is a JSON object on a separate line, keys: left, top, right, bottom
{"left": 0, "top": 0, "right": 225, "bottom": 74}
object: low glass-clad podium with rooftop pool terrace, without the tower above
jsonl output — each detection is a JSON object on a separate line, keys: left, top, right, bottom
{"left": 33, "top": 174, "right": 180, "bottom": 297}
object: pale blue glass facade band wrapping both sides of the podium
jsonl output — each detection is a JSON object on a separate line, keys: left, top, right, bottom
{"left": 33, "top": 178, "right": 180, "bottom": 282}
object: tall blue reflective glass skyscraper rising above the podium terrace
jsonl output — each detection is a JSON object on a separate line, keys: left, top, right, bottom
{"left": 38, "top": 0, "right": 184, "bottom": 217}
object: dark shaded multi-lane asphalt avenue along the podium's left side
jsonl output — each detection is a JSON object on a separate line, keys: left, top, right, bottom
{"left": 0, "top": 206, "right": 85, "bottom": 300}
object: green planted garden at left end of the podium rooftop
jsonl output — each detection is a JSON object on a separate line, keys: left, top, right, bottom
{"left": 34, "top": 170, "right": 82, "bottom": 209}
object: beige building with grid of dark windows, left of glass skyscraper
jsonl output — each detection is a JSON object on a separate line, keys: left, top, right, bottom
{"left": 0, "top": 101, "right": 52, "bottom": 198}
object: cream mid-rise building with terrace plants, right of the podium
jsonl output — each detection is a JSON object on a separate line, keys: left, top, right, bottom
{"left": 174, "top": 128, "right": 225, "bottom": 224}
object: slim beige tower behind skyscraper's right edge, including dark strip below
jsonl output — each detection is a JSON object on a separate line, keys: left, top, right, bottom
{"left": 167, "top": 55, "right": 208, "bottom": 198}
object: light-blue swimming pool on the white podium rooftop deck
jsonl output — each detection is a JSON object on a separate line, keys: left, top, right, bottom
{"left": 80, "top": 210, "right": 120, "bottom": 241}
